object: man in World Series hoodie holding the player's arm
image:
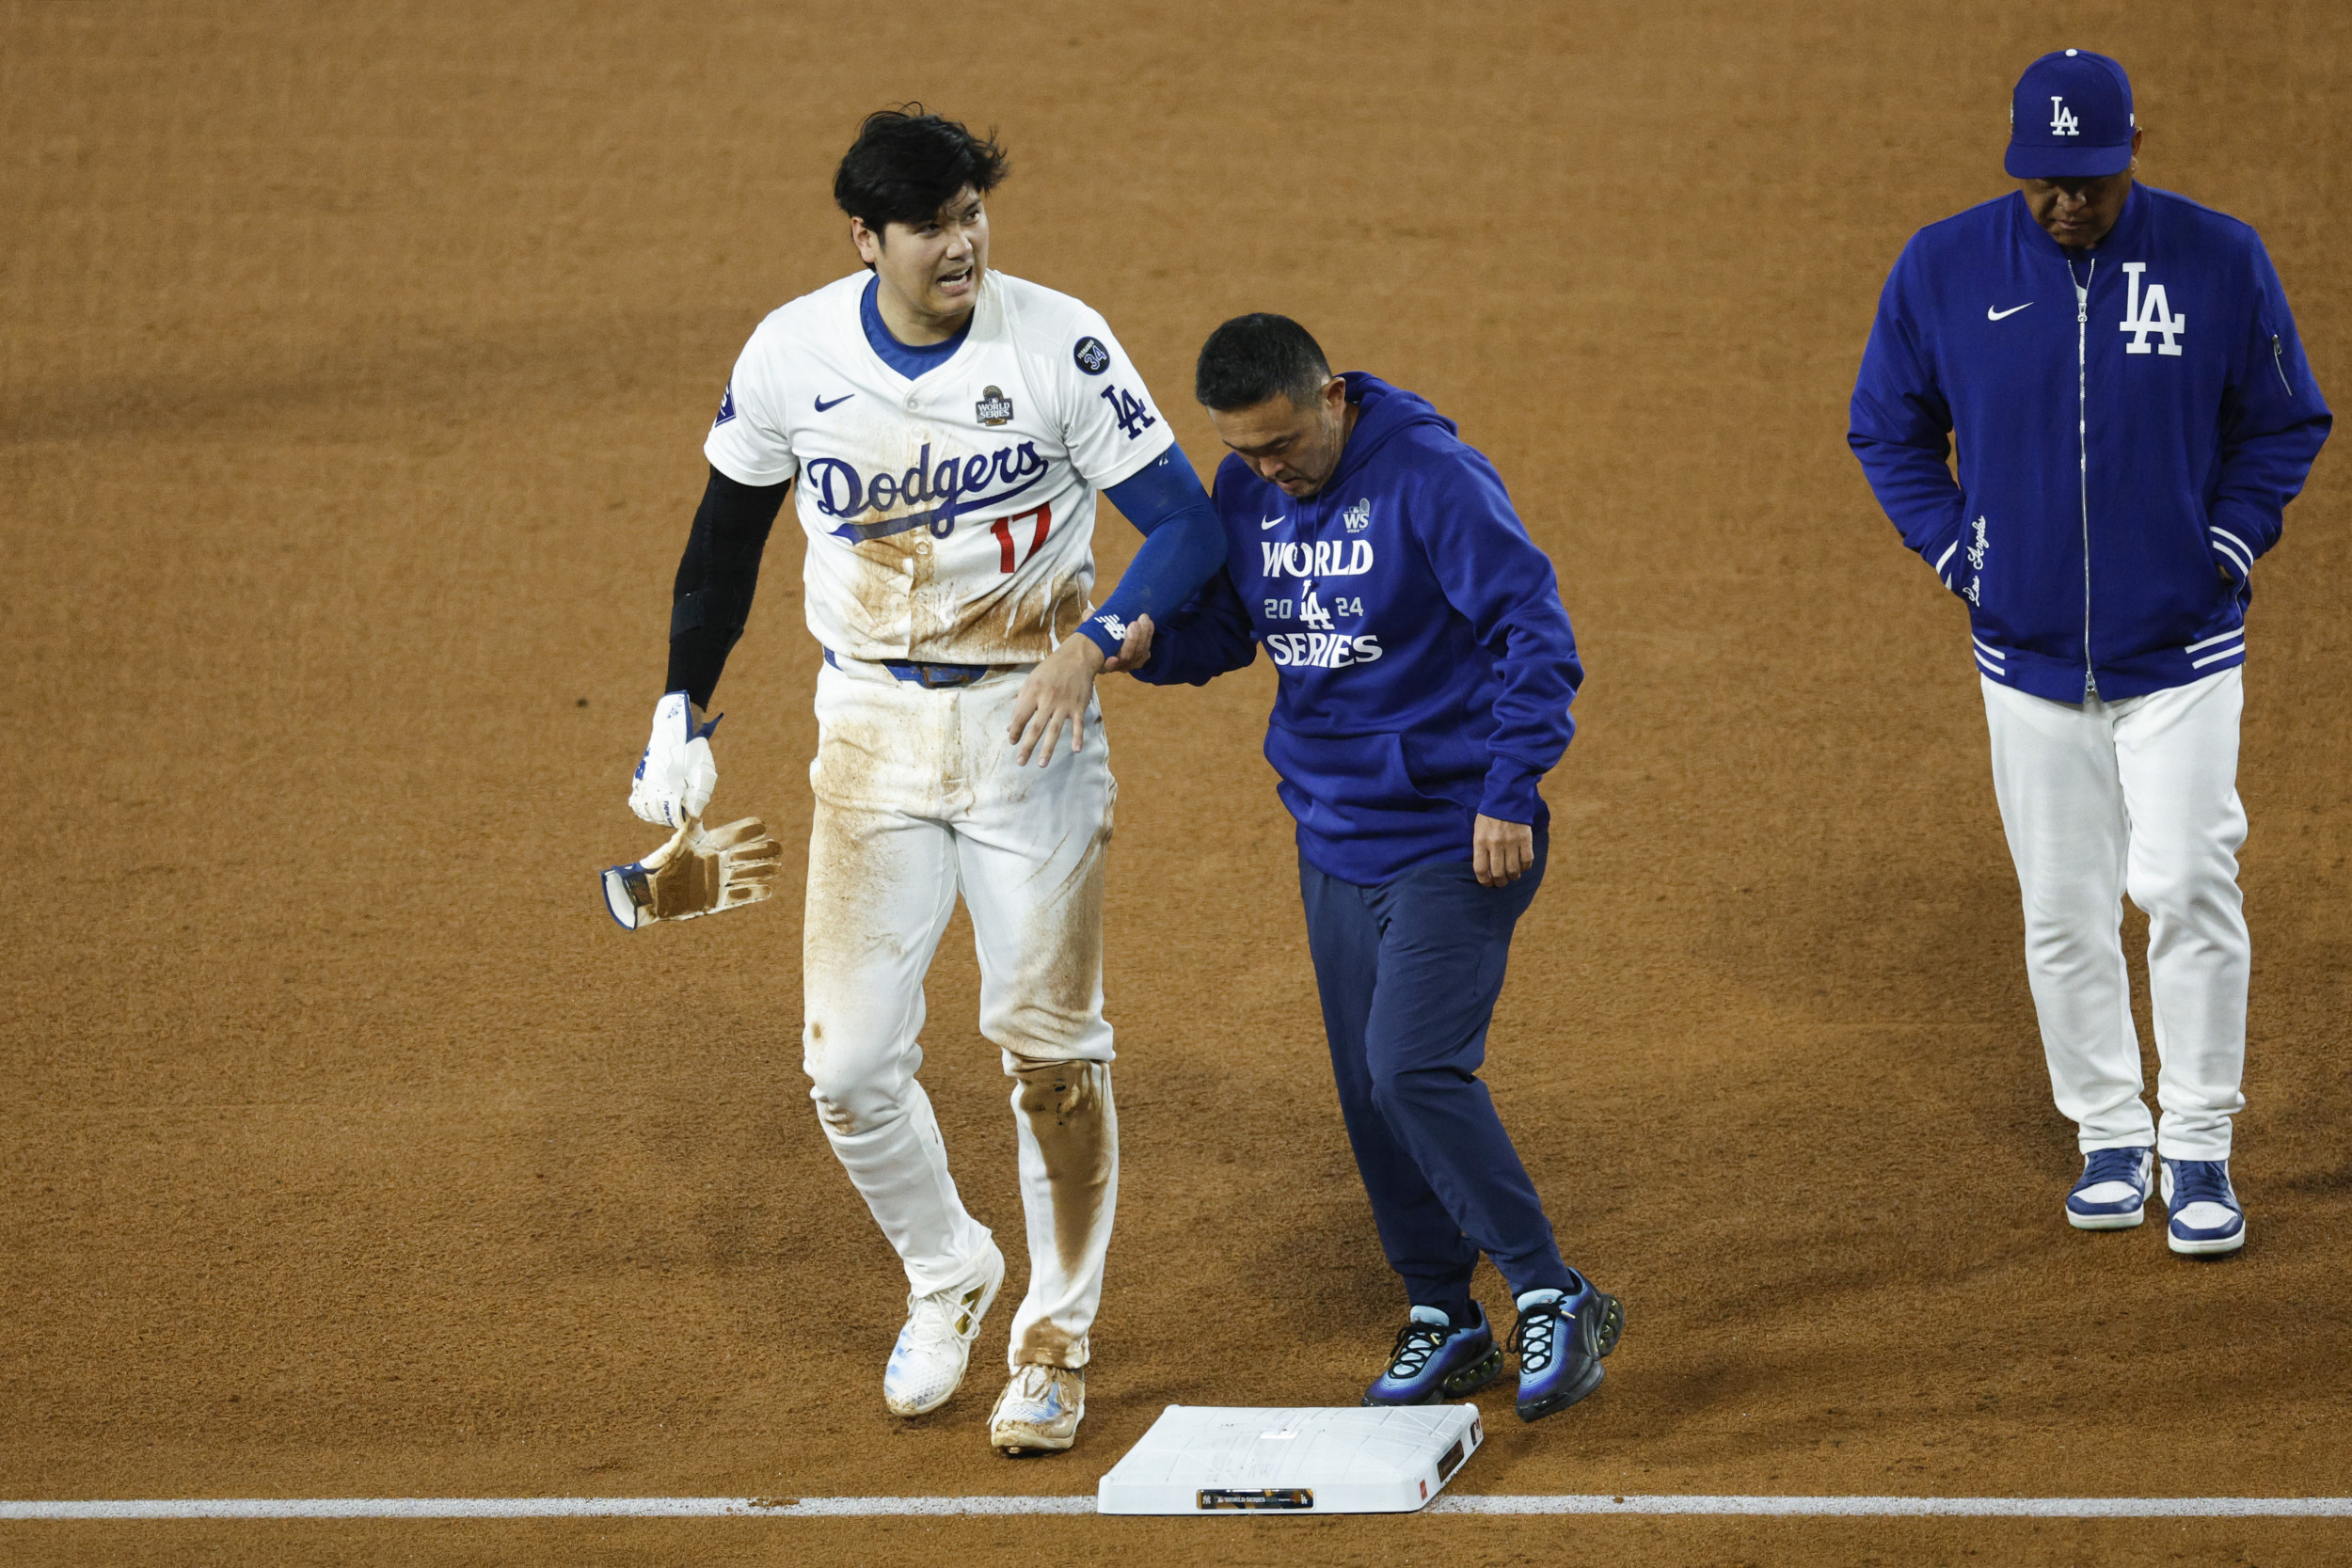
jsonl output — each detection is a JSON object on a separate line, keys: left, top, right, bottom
{"left": 1122, "top": 315, "right": 1623, "bottom": 1420}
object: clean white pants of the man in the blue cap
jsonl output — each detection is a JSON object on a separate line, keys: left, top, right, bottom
{"left": 1985, "top": 668, "right": 2253, "bottom": 1159}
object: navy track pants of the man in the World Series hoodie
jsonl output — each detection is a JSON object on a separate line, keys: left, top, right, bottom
{"left": 1298, "top": 830, "right": 1574, "bottom": 1309}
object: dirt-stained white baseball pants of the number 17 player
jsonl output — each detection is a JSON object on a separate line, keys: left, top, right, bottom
{"left": 803, "top": 660, "right": 1120, "bottom": 1369}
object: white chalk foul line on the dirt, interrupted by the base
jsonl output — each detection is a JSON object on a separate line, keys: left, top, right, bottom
{"left": 0, "top": 1493, "right": 2352, "bottom": 1521}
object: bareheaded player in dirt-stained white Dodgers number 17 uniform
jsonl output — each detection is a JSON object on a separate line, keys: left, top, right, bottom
{"left": 633, "top": 105, "right": 1223, "bottom": 1453}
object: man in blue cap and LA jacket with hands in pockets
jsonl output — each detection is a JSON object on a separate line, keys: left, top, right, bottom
{"left": 1849, "top": 49, "right": 2328, "bottom": 1256}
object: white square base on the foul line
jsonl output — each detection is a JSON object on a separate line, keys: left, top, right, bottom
{"left": 1096, "top": 1403, "right": 1486, "bottom": 1514}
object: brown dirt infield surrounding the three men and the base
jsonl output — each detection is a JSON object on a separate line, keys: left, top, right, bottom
{"left": 0, "top": 0, "right": 2352, "bottom": 1566}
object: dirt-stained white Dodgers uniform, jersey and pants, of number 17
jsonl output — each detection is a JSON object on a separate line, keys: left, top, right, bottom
{"left": 704, "top": 273, "right": 1171, "bottom": 1369}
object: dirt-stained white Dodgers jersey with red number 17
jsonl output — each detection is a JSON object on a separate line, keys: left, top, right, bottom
{"left": 704, "top": 270, "right": 1176, "bottom": 665}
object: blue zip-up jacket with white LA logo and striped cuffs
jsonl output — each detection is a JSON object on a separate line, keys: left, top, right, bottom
{"left": 1847, "top": 185, "right": 2331, "bottom": 703}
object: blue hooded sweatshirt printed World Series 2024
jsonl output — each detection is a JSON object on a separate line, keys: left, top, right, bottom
{"left": 1136, "top": 372, "right": 1585, "bottom": 886}
